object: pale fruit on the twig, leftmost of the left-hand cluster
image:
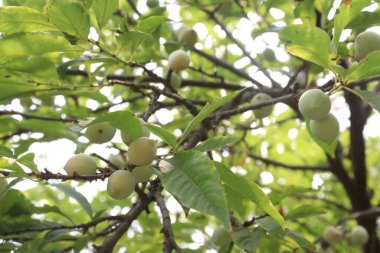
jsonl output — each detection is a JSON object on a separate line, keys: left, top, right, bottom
{"left": 63, "top": 154, "right": 96, "bottom": 176}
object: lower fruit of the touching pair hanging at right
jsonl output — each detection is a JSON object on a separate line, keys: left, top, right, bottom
{"left": 310, "top": 113, "right": 339, "bottom": 144}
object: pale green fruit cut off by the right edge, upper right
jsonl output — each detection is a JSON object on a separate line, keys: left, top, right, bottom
{"left": 354, "top": 31, "right": 380, "bottom": 59}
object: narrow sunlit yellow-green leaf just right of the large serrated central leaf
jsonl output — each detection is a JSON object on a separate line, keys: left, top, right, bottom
{"left": 215, "top": 163, "right": 286, "bottom": 228}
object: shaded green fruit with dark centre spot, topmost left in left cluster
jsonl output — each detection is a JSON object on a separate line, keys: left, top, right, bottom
{"left": 84, "top": 122, "right": 116, "bottom": 144}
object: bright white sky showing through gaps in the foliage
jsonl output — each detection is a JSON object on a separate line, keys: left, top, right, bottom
{"left": 0, "top": 0, "right": 380, "bottom": 252}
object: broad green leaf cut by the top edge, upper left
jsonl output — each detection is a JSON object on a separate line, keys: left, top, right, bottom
{"left": 46, "top": 0, "right": 90, "bottom": 40}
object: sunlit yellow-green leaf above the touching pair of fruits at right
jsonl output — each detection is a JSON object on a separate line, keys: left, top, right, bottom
{"left": 280, "top": 25, "right": 330, "bottom": 68}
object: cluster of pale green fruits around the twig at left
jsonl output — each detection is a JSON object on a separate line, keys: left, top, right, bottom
{"left": 63, "top": 119, "right": 157, "bottom": 199}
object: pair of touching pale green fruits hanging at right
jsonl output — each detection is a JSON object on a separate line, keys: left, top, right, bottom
{"left": 298, "top": 89, "right": 339, "bottom": 144}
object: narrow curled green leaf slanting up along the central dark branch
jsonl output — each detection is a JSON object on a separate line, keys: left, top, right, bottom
{"left": 174, "top": 90, "right": 243, "bottom": 150}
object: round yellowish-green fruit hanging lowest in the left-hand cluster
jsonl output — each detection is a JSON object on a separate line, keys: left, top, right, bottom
{"left": 107, "top": 170, "right": 136, "bottom": 199}
